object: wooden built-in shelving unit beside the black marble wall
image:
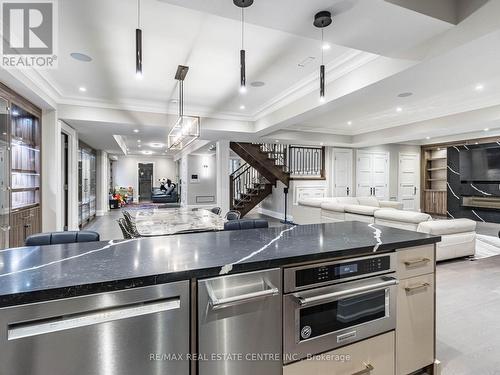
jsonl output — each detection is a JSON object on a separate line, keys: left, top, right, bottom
{"left": 421, "top": 147, "right": 448, "bottom": 215}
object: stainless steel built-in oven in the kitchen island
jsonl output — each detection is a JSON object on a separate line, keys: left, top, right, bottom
{"left": 283, "top": 253, "right": 398, "bottom": 364}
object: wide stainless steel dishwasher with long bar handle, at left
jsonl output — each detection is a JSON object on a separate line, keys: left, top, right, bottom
{"left": 0, "top": 281, "right": 189, "bottom": 375}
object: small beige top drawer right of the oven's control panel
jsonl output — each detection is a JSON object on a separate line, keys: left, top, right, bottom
{"left": 396, "top": 245, "right": 434, "bottom": 280}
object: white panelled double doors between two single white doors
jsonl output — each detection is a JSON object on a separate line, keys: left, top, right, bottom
{"left": 356, "top": 151, "right": 389, "bottom": 199}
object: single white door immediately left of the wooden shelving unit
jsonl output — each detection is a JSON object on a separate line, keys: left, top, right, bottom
{"left": 398, "top": 153, "right": 420, "bottom": 211}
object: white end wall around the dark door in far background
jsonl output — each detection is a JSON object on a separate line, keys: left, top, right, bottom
{"left": 113, "top": 155, "right": 178, "bottom": 201}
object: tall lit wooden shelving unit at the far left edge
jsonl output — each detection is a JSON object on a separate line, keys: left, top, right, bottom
{"left": 0, "top": 84, "right": 42, "bottom": 249}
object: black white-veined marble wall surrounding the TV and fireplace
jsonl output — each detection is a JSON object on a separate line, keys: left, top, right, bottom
{"left": 447, "top": 143, "right": 500, "bottom": 223}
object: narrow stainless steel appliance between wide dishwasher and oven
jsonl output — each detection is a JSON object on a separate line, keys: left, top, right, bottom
{"left": 198, "top": 269, "right": 282, "bottom": 375}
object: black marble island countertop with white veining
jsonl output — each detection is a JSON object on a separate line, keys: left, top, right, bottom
{"left": 0, "top": 221, "right": 440, "bottom": 307}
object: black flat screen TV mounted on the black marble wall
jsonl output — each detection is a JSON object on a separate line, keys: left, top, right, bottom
{"left": 460, "top": 147, "right": 500, "bottom": 182}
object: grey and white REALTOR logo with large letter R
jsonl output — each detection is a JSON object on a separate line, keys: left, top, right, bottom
{"left": 2, "top": 0, "right": 57, "bottom": 68}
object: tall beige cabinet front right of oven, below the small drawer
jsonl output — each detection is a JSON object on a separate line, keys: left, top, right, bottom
{"left": 396, "top": 274, "right": 435, "bottom": 375}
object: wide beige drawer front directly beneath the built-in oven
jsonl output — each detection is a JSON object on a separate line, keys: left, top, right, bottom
{"left": 283, "top": 332, "right": 395, "bottom": 375}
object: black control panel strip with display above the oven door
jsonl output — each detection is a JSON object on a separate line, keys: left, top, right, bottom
{"left": 294, "top": 255, "right": 392, "bottom": 288}
